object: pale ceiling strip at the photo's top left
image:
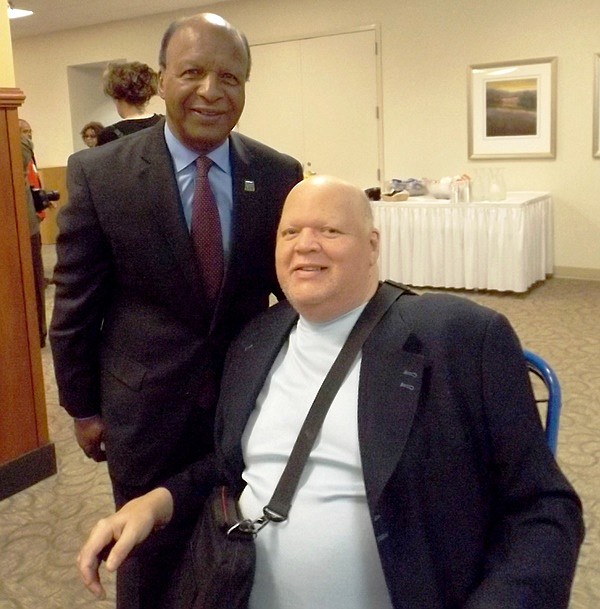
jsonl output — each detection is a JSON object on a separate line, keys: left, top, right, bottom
{"left": 10, "top": 0, "right": 234, "bottom": 40}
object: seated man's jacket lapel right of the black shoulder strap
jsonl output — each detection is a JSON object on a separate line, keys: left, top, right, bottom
{"left": 358, "top": 316, "right": 424, "bottom": 510}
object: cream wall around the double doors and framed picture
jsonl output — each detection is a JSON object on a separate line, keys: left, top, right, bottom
{"left": 13, "top": 0, "right": 600, "bottom": 278}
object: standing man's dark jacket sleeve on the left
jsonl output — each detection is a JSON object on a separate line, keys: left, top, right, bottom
{"left": 50, "top": 154, "right": 111, "bottom": 418}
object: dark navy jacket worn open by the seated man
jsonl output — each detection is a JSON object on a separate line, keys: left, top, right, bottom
{"left": 168, "top": 286, "right": 583, "bottom": 609}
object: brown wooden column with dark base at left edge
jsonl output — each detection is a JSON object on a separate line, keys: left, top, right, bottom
{"left": 0, "top": 88, "right": 56, "bottom": 499}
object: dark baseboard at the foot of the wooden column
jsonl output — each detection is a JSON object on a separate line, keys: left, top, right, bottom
{"left": 0, "top": 443, "right": 56, "bottom": 501}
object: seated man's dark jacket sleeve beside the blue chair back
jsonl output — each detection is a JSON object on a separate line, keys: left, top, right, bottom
{"left": 464, "top": 315, "right": 584, "bottom": 609}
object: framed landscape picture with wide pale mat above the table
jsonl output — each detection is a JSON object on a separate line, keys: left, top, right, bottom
{"left": 468, "top": 57, "right": 556, "bottom": 159}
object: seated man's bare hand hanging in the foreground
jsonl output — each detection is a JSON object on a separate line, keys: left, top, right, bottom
{"left": 77, "top": 487, "right": 173, "bottom": 599}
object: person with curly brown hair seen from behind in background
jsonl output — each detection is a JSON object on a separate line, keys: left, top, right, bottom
{"left": 98, "top": 61, "right": 161, "bottom": 146}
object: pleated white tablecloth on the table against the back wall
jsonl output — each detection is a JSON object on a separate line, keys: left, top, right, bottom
{"left": 372, "top": 192, "right": 553, "bottom": 292}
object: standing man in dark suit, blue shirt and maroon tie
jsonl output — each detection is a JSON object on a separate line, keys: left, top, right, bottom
{"left": 50, "top": 14, "right": 302, "bottom": 608}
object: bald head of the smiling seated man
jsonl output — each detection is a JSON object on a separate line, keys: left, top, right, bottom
{"left": 276, "top": 175, "right": 379, "bottom": 322}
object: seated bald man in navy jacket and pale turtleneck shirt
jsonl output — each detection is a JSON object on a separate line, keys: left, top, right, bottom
{"left": 79, "top": 176, "right": 583, "bottom": 609}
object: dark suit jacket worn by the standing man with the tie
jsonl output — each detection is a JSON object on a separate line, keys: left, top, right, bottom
{"left": 50, "top": 120, "right": 302, "bottom": 488}
